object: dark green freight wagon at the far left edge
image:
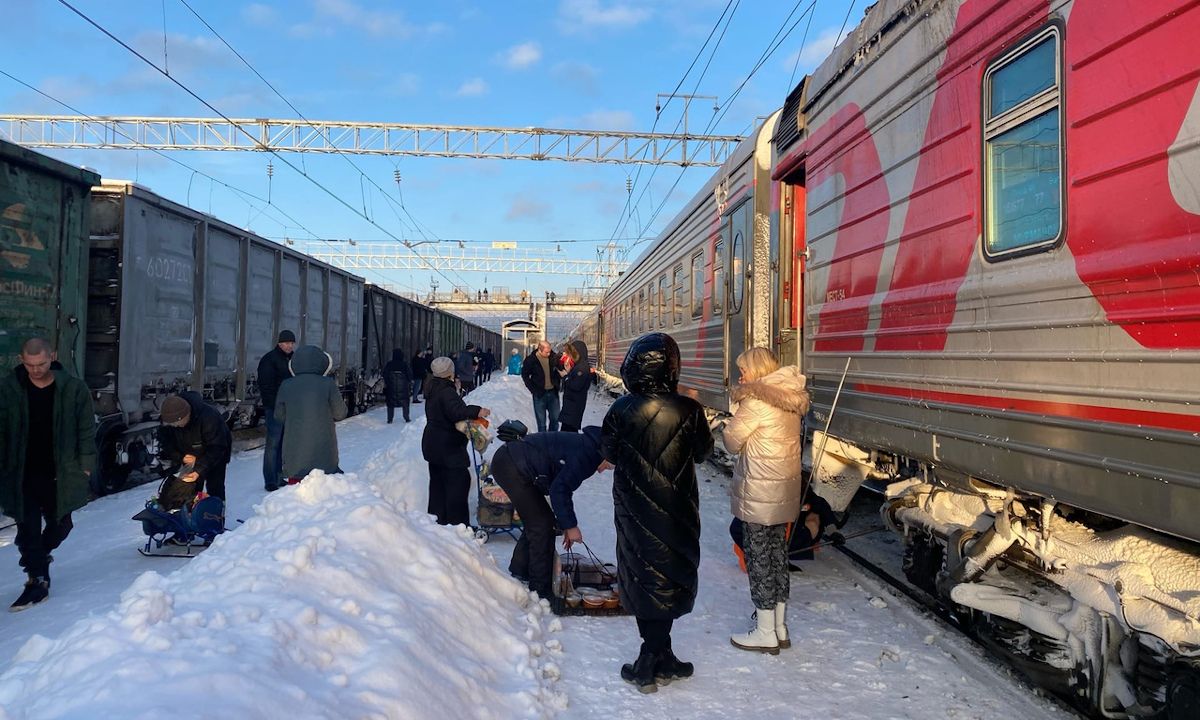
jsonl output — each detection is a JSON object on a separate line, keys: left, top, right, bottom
{"left": 0, "top": 140, "right": 100, "bottom": 378}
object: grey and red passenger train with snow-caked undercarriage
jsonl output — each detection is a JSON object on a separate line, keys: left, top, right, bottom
{"left": 575, "top": 0, "right": 1200, "bottom": 720}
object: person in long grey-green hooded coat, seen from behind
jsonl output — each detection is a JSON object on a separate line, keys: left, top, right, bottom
{"left": 275, "top": 346, "right": 349, "bottom": 484}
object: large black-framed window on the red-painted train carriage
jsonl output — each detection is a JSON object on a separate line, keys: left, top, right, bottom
{"left": 983, "top": 26, "right": 1063, "bottom": 259}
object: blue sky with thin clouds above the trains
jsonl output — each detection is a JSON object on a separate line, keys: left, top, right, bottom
{"left": 0, "top": 0, "right": 866, "bottom": 293}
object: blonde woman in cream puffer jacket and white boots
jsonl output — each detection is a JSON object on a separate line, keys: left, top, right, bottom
{"left": 724, "top": 348, "right": 809, "bottom": 655}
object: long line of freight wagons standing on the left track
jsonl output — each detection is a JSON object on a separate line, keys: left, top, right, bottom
{"left": 0, "top": 140, "right": 502, "bottom": 494}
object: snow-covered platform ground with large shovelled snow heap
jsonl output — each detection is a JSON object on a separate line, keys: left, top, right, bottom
{"left": 0, "top": 374, "right": 1068, "bottom": 720}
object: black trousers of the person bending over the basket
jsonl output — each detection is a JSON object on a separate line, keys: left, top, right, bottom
{"left": 492, "top": 445, "right": 554, "bottom": 594}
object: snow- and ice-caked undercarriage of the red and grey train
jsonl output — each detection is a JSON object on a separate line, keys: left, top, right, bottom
{"left": 844, "top": 458, "right": 1200, "bottom": 720}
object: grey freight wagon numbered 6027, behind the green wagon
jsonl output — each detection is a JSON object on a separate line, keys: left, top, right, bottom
{"left": 84, "top": 181, "right": 364, "bottom": 491}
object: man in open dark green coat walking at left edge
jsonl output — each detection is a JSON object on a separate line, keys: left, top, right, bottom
{"left": 0, "top": 337, "right": 96, "bottom": 611}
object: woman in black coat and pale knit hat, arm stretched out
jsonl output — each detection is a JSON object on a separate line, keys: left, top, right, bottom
{"left": 421, "top": 358, "right": 491, "bottom": 524}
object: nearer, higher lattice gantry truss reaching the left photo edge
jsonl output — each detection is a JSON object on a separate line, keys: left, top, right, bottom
{"left": 0, "top": 115, "right": 743, "bottom": 167}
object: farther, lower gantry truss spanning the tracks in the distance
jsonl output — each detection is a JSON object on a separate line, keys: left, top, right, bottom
{"left": 287, "top": 240, "right": 629, "bottom": 277}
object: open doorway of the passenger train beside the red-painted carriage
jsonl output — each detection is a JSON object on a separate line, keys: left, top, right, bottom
{"left": 770, "top": 78, "right": 808, "bottom": 370}
